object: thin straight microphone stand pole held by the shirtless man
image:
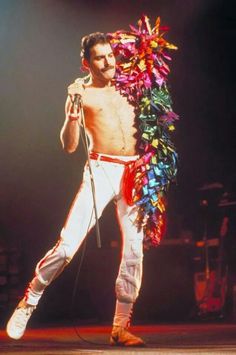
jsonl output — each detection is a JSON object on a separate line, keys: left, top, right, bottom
{"left": 78, "top": 97, "right": 101, "bottom": 248}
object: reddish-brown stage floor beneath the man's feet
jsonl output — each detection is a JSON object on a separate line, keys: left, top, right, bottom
{"left": 0, "top": 323, "right": 236, "bottom": 355}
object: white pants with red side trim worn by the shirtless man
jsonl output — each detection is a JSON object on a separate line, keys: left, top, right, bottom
{"left": 25, "top": 156, "right": 143, "bottom": 326}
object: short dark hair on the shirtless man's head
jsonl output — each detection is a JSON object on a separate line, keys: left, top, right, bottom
{"left": 80, "top": 32, "right": 109, "bottom": 61}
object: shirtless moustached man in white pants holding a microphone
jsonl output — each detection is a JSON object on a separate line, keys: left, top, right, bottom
{"left": 7, "top": 33, "right": 144, "bottom": 346}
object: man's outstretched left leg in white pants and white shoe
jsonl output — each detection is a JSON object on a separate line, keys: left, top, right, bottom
{"left": 7, "top": 163, "right": 113, "bottom": 339}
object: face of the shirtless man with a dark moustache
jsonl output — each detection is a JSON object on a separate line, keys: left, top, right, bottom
{"left": 86, "top": 43, "right": 116, "bottom": 82}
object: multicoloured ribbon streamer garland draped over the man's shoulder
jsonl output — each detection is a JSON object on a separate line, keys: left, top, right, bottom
{"left": 108, "top": 16, "right": 178, "bottom": 246}
